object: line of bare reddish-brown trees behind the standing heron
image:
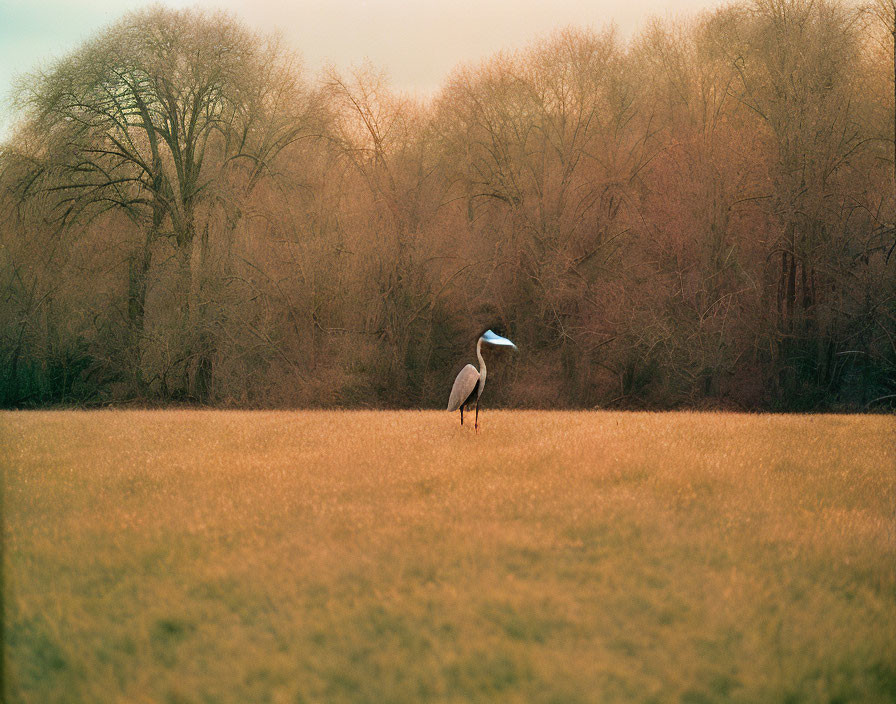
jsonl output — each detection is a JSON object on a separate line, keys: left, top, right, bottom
{"left": 0, "top": 0, "right": 896, "bottom": 410}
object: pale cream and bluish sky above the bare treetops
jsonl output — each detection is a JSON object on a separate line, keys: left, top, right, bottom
{"left": 0, "top": 0, "right": 720, "bottom": 137}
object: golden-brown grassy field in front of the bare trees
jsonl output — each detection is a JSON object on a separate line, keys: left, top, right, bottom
{"left": 0, "top": 411, "right": 896, "bottom": 704}
